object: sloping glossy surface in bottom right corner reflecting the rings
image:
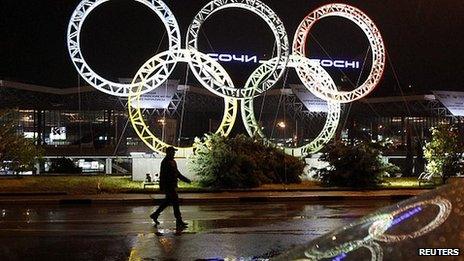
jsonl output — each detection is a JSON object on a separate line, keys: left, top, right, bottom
{"left": 275, "top": 179, "right": 464, "bottom": 261}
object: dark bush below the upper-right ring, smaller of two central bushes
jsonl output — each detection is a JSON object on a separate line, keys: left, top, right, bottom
{"left": 316, "top": 141, "right": 399, "bottom": 188}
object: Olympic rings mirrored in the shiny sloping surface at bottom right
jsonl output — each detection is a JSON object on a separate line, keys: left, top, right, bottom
{"left": 300, "top": 196, "right": 452, "bottom": 261}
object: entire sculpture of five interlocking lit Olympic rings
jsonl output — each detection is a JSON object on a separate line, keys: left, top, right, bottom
{"left": 67, "top": 0, "right": 385, "bottom": 156}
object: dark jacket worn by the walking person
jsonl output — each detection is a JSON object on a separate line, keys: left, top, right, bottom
{"left": 160, "top": 155, "right": 190, "bottom": 193}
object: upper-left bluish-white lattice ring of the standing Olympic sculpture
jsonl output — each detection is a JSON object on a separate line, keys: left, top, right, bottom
{"left": 67, "top": 0, "right": 181, "bottom": 97}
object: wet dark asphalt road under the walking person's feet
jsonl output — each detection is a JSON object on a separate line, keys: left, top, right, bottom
{"left": 0, "top": 200, "right": 394, "bottom": 261}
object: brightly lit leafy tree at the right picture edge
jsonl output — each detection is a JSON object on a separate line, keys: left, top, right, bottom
{"left": 424, "top": 124, "right": 464, "bottom": 182}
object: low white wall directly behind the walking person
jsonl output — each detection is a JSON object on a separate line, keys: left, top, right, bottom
{"left": 132, "top": 157, "right": 195, "bottom": 181}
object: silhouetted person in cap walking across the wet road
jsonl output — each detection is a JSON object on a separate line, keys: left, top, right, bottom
{"left": 150, "top": 147, "right": 191, "bottom": 228}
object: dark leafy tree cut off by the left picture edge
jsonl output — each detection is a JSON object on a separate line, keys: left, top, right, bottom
{"left": 0, "top": 108, "right": 43, "bottom": 174}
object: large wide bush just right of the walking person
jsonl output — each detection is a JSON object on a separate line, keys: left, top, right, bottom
{"left": 189, "top": 135, "right": 305, "bottom": 188}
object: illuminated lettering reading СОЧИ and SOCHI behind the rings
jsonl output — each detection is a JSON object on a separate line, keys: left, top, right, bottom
{"left": 207, "top": 53, "right": 360, "bottom": 69}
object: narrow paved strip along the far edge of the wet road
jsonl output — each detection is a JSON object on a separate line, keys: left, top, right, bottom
{"left": 0, "top": 189, "right": 430, "bottom": 205}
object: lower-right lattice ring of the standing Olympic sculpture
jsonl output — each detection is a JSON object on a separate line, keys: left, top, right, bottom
{"left": 241, "top": 55, "right": 341, "bottom": 157}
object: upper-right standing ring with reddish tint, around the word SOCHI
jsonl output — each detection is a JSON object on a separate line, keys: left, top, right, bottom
{"left": 293, "top": 4, "right": 385, "bottom": 103}
